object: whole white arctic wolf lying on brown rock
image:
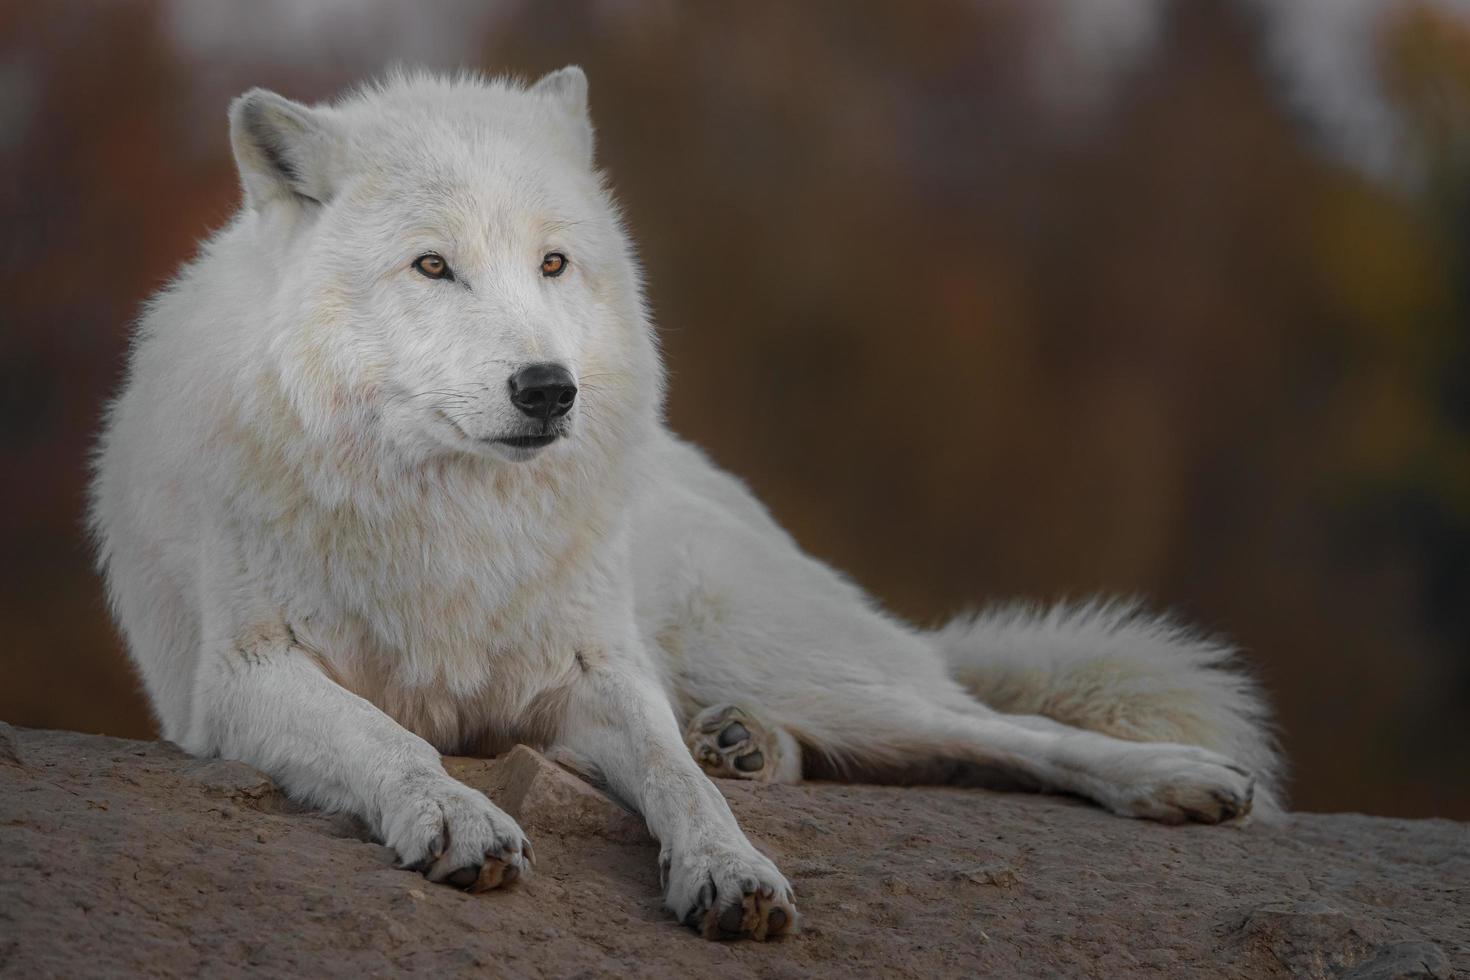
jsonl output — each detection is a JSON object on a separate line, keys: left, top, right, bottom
{"left": 91, "top": 68, "right": 1277, "bottom": 939}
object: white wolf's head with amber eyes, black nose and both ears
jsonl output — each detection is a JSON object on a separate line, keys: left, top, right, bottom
{"left": 229, "top": 68, "right": 662, "bottom": 463}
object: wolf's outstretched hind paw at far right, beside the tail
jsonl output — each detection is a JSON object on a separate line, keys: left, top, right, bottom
{"left": 1101, "top": 743, "right": 1255, "bottom": 823}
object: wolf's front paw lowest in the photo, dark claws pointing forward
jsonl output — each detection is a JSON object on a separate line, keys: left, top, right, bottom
{"left": 659, "top": 842, "right": 797, "bottom": 942}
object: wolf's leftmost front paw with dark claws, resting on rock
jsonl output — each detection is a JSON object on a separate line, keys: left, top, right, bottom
{"left": 384, "top": 776, "right": 534, "bottom": 892}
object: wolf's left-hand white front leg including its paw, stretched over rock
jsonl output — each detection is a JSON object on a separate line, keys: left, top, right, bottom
{"left": 182, "top": 620, "right": 531, "bottom": 890}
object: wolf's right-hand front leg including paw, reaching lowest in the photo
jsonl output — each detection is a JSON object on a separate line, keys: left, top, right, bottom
{"left": 559, "top": 655, "right": 797, "bottom": 940}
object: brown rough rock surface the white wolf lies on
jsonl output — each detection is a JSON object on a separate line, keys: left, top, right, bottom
{"left": 0, "top": 724, "right": 1470, "bottom": 980}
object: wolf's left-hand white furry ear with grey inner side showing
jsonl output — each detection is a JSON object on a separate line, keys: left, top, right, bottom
{"left": 229, "top": 88, "right": 338, "bottom": 210}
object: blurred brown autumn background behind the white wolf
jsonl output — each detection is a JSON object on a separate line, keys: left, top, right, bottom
{"left": 0, "top": 0, "right": 1470, "bottom": 820}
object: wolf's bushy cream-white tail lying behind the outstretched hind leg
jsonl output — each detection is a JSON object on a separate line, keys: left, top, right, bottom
{"left": 933, "top": 599, "right": 1283, "bottom": 818}
